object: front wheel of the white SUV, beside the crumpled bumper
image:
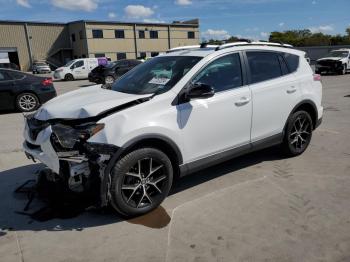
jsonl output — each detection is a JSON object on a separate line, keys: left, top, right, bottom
{"left": 110, "top": 148, "right": 173, "bottom": 218}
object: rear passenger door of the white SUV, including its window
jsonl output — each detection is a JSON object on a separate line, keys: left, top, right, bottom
{"left": 246, "top": 51, "right": 300, "bottom": 143}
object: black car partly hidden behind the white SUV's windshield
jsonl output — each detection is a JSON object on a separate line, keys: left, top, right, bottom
{"left": 89, "top": 59, "right": 142, "bottom": 84}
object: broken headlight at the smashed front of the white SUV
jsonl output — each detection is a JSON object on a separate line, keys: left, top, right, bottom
{"left": 52, "top": 123, "right": 105, "bottom": 148}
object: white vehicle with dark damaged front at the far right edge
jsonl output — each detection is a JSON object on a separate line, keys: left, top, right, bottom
{"left": 315, "top": 49, "right": 350, "bottom": 75}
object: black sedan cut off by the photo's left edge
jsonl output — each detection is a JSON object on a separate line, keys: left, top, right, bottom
{"left": 0, "top": 69, "right": 57, "bottom": 112}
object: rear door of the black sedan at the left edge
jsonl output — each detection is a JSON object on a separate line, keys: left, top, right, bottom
{"left": 0, "top": 70, "right": 15, "bottom": 110}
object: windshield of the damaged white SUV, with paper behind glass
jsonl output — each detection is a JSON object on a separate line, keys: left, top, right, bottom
{"left": 112, "top": 56, "right": 202, "bottom": 95}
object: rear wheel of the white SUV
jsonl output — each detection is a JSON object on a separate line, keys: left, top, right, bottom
{"left": 282, "top": 111, "right": 313, "bottom": 156}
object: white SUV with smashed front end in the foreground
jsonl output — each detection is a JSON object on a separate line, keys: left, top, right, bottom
{"left": 24, "top": 43, "right": 323, "bottom": 216}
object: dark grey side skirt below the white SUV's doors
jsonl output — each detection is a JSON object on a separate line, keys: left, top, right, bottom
{"left": 179, "top": 133, "right": 284, "bottom": 177}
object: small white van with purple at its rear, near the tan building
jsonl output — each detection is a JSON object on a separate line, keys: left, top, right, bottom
{"left": 54, "top": 57, "right": 108, "bottom": 81}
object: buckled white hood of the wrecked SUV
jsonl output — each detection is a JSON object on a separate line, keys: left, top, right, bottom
{"left": 35, "top": 85, "right": 150, "bottom": 121}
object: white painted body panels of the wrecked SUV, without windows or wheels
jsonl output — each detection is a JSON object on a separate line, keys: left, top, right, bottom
{"left": 24, "top": 45, "right": 323, "bottom": 184}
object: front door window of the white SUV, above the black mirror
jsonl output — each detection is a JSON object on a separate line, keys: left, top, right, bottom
{"left": 192, "top": 53, "right": 243, "bottom": 93}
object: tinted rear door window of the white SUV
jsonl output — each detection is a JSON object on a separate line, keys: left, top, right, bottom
{"left": 247, "top": 52, "right": 282, "bottom": 84}
